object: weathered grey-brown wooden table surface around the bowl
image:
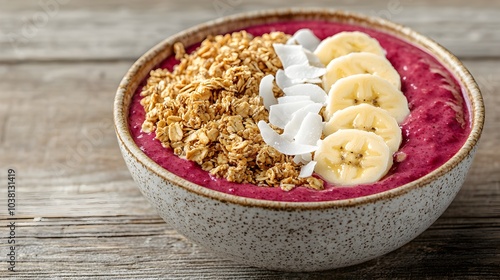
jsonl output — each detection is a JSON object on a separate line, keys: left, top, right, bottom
{"left": 0, "top": 0, "right": 500, "bottom": 279}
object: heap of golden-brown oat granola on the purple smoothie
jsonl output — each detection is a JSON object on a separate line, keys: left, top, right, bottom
{"left": 141, "top": 31, "right": 323, "bottom": 190}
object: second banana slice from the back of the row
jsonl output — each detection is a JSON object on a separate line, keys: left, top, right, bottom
{"left": 323, "top": 53, "right": 401, "bottom": 92}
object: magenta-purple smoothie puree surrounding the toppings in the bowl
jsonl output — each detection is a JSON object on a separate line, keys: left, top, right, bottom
{"left": 129, "top": 21, "right": 470, "bottom": 202}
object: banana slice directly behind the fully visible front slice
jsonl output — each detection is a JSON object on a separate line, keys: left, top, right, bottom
{"left": 323, "top": 104, "right": 402, "bottom": 155}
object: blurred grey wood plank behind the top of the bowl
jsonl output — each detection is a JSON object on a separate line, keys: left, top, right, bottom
{"left": 0, "top": 0, "right": 500, "bottom": 62}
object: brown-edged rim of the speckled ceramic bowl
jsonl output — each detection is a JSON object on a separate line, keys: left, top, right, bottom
{"left": 113, "top": 8, "right": 485, "bottom": 211}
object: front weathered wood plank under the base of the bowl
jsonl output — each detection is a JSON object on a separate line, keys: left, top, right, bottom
{"left": 0, "top": 216, "right": 500, "bottom": 279}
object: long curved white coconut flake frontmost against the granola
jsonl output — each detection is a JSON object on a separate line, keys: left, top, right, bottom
{"left": 257, "top": 121, "right": 318, "bottom": 155}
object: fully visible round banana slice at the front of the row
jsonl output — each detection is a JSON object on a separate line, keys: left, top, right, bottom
{"left": 314, "top": 129, "right": 392, "bottom": 186}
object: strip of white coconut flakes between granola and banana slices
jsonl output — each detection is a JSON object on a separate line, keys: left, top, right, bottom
{"left": 258, "top": 29, "right": 327, "bottom": 165}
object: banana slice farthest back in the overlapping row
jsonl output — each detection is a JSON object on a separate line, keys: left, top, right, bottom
{"left": 314, "top": 31, "right": 385, "bottom": 65}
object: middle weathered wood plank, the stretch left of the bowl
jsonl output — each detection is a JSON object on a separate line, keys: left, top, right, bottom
{"left": 0, "top": 62, "right": 151, "bottom": 217}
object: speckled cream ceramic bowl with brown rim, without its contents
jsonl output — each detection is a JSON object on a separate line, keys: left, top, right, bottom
{"left": 114, "top": 9, "right": 484, "bottom": 271}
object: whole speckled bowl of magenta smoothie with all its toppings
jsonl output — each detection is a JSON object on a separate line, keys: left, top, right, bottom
{"left": 114, "top": 9, "right": 484, "bottom": 271}
